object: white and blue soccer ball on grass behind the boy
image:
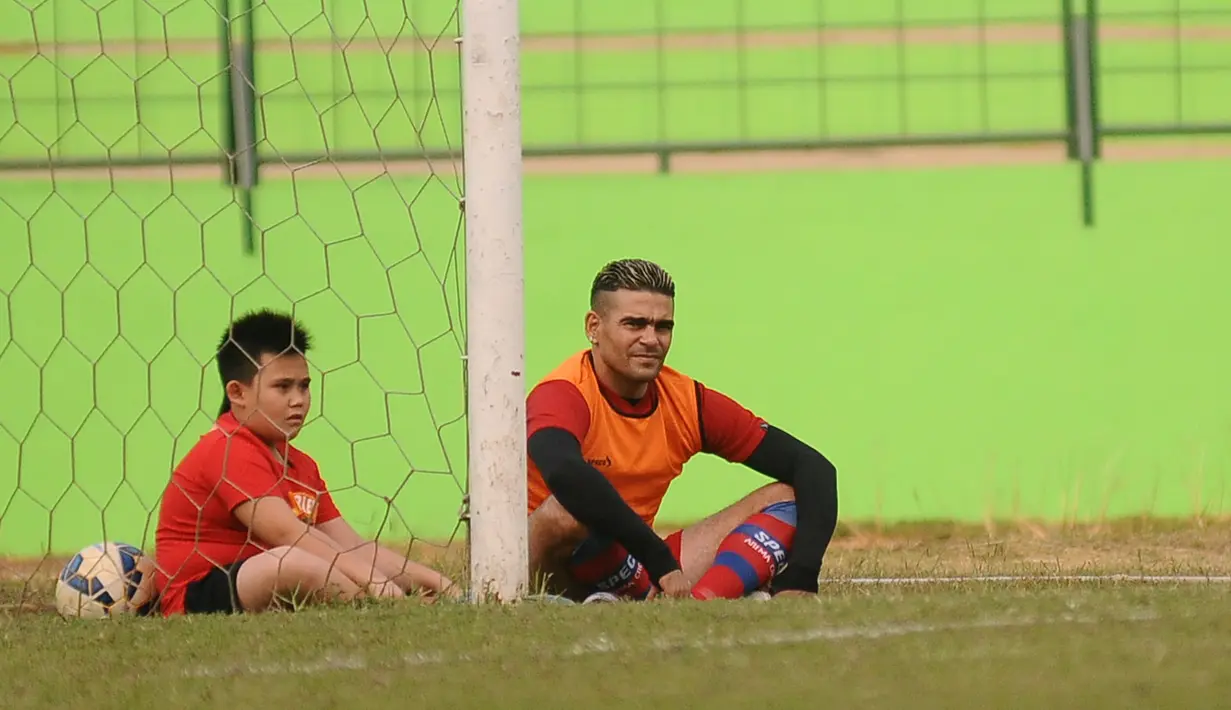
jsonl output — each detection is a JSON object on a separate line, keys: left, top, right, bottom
{"left": 55, "top": 543, "right": 154, "bottom": 619}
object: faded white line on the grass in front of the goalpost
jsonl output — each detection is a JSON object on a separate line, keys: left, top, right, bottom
{"left": 183, "top": 612, "right": 1158, "bottom": 678}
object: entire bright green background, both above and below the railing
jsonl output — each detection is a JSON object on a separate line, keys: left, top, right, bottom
{"left": 0, "top": 0, "right": 1231, "bottom": 555}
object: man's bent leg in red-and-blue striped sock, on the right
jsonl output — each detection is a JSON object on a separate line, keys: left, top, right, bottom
{"left": 676, "top": 484, "right": 795, "bottom": 598}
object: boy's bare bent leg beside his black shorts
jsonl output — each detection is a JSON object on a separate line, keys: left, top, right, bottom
{"left": 229, "top": 548, "right": 363, "bottom": 612}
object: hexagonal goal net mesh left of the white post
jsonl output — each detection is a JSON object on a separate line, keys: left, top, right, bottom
{"left": 0, "top": 0, "right": 467, "bottom": 608}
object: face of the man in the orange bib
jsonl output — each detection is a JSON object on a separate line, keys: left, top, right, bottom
{"left": 586, "top": 290, "right": 676, "bottom": 383}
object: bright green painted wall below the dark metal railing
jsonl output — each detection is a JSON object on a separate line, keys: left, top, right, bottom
{"left": 0, "top": 156, "right": 1231, "bottom": 555}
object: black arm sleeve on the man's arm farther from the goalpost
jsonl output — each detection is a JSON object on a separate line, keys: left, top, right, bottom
{"left": 744, "top": 426, "right": 838, "bottom": 592}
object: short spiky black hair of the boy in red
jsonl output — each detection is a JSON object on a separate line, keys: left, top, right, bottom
{"left": 218, "top": 309, "right": 311, "bottom": 416}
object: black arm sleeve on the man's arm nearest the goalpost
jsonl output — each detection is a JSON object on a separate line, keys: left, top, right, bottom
{"left": 526, "top": 427, "right": 680, "bottom": 583}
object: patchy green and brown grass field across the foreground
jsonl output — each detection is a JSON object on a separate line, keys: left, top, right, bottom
{"left": 7, "top": 516, "right": 1231, "bottom": 710}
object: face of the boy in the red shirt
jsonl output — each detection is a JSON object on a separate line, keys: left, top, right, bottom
{"left": 227, "top": 353, "right": 311, "bottom": 443}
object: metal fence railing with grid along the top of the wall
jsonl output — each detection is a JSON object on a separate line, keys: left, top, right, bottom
{"left": 0, "top": 0, "right": 1231, "bottom": 173}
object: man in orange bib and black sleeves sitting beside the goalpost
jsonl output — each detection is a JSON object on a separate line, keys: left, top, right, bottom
{"left": 526, "top": 260, "right": 838, "bottom": 600}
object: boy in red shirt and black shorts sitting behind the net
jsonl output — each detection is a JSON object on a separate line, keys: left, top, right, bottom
{"left": 155, "top": 310, "right": 460, "bottom": 616}
